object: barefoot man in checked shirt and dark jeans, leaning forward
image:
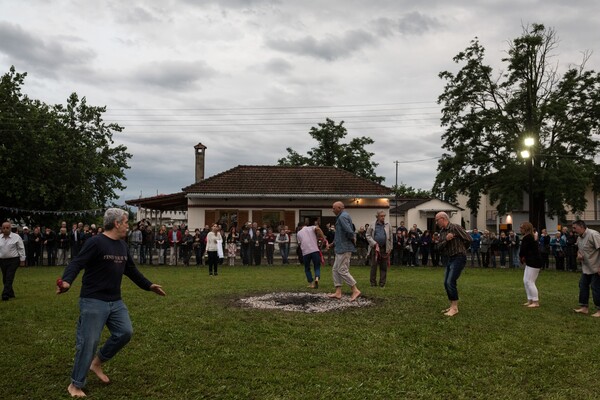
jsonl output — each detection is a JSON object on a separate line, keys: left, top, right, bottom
{"left": 435, "top": 212, "right": 472, "bottom": 317}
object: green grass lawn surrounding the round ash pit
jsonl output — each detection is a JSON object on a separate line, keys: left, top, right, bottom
{"left": 0, "top": 265, "right": 600, "bottom": 400}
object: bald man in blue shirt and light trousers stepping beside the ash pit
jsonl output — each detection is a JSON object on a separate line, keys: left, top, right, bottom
{"left": 328, "top": 201, "right": 360, "bottom": 301}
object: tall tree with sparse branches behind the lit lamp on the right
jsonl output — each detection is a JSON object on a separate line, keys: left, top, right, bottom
{"left": 433, "top": 24, "right": 600, "bottom": 228}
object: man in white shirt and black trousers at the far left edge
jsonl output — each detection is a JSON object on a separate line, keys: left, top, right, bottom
{"left": 0, "top": 222, "right": 25, "bottom": 301}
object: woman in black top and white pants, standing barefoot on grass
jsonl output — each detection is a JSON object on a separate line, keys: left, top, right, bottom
{"left": 519, "top": 222, "right": 542, "bottom": 308}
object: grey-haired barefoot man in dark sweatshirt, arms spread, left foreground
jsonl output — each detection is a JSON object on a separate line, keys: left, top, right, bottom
{"left": 56, "top": 208, "right": 165, "bottom": 397}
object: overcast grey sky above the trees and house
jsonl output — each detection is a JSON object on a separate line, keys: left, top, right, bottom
{"left": 0, "top": 0, "right": 600, "bottom": 205}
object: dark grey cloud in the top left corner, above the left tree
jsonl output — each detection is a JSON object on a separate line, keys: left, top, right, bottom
{"left": 0, "top": 21, "right": 96, "bottom": 77}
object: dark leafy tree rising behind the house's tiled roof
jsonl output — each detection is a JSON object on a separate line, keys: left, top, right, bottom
{"left": 278, "top": 118, "right": 384, "bottom": 183}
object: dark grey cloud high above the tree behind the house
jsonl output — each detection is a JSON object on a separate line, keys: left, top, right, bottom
{"left": 266, "top": 30, "right": 377, "bottom": 61}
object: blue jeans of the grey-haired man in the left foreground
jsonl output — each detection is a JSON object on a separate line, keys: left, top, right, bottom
{"left": 71, "top": 298, "right": 133, "bottom": 388}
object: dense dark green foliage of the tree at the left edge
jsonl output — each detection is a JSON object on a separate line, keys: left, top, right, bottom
{"left": 0, "top": 67, "right": 131, "bottom": 227}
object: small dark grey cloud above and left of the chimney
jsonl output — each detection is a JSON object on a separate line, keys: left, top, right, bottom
{"left": 134, "top": 61, "right": 217, "bottom": 90}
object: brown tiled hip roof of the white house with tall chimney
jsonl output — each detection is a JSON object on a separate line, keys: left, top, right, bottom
{"left": 182, "top": 165, "right": 392, "bottom": 197}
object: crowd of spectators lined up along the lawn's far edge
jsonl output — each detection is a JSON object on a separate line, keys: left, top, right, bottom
{"left": 8, "top": 220, "right": 578, "bottom": 271}
